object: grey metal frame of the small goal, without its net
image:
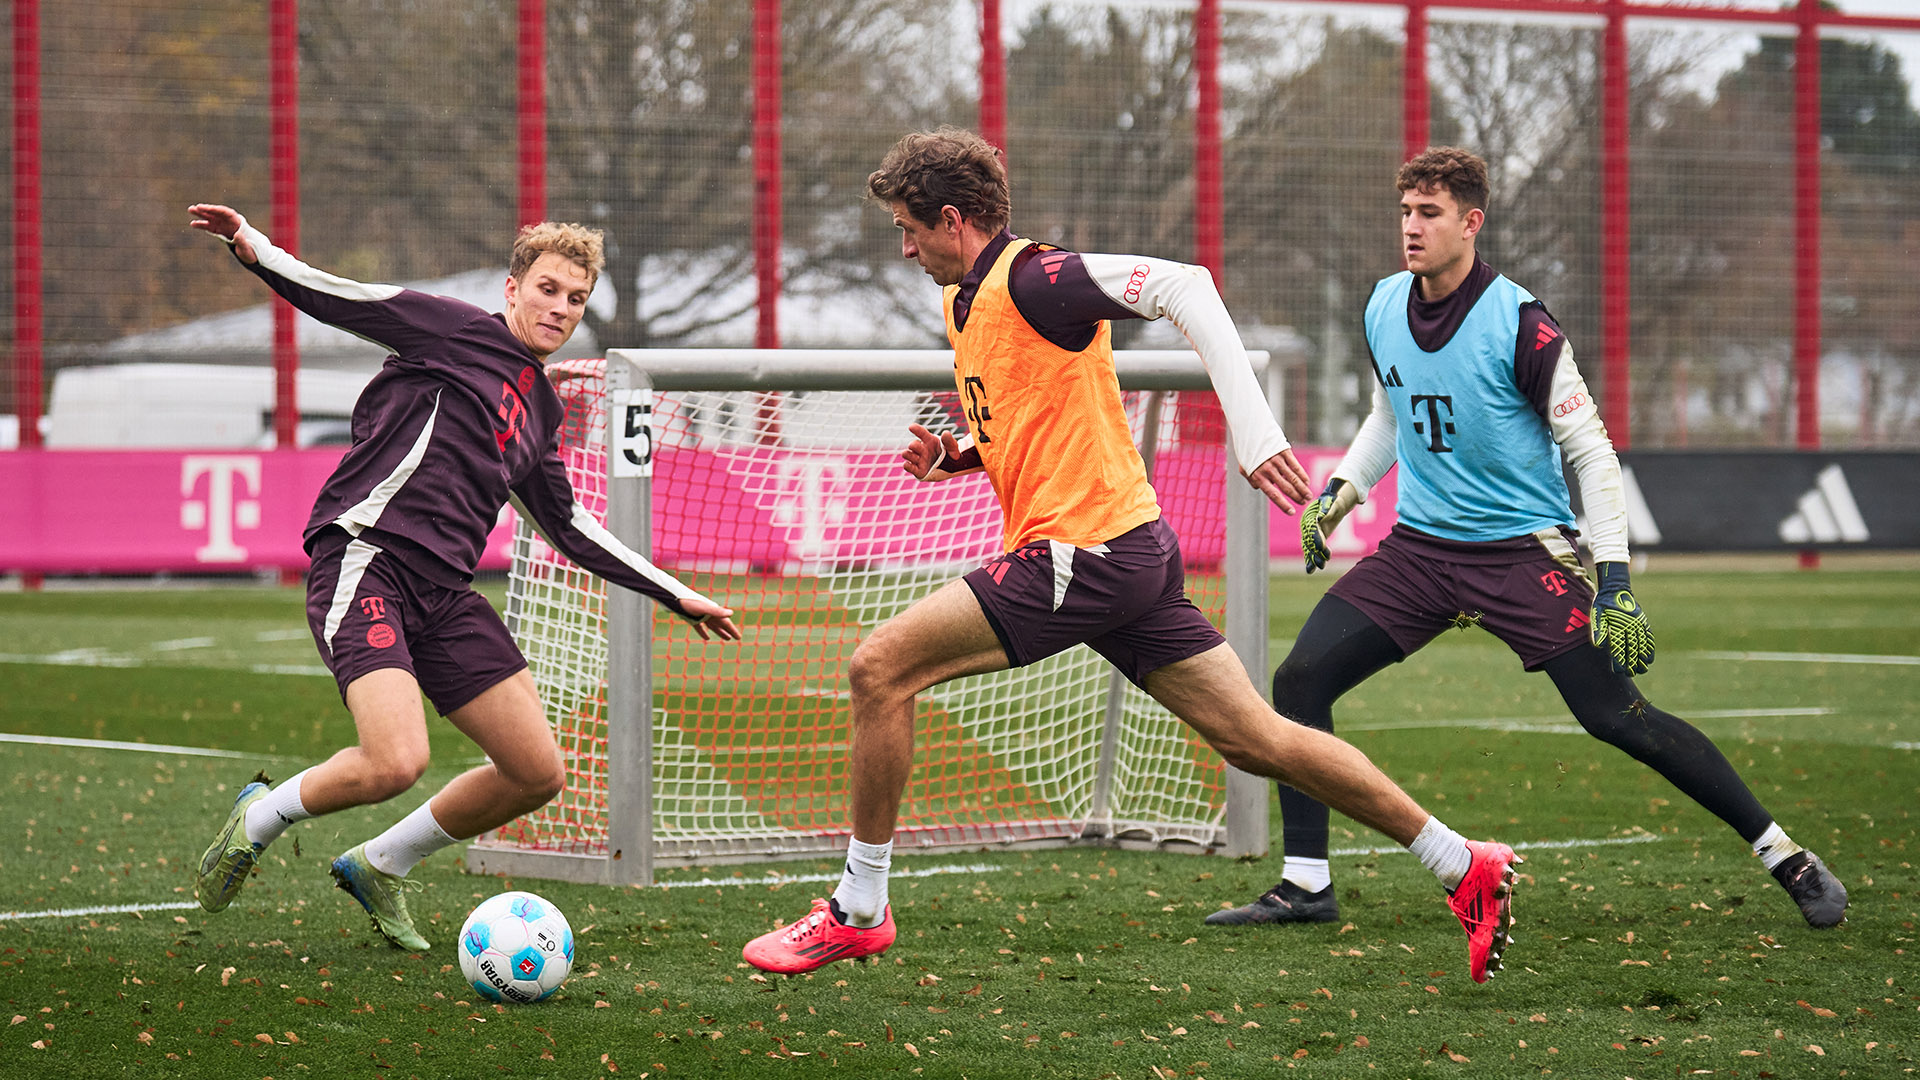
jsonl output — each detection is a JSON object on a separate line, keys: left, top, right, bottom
{"left": 467, "top": 350, "right": 1271, "bottom": 886}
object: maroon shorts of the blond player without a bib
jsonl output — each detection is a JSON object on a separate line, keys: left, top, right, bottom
{"left": 307, "top": 532, "right": 526, "bottom": 717}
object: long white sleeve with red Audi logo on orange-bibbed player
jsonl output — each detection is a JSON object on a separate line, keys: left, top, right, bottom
{"left": 1081, "top": 256, "right": 1290, "bottom": 471}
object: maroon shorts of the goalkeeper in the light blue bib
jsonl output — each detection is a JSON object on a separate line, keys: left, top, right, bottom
{"left": 1327, "top": 525, "right": 1594, "bottom": 671}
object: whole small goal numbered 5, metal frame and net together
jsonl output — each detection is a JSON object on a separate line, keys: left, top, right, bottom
{"left": 467, "top": 350, "right": 1269, "bottom": 884}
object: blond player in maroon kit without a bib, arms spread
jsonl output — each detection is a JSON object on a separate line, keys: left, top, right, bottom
{"left": 188, "top": 204, "right": 739, "bottom": 949}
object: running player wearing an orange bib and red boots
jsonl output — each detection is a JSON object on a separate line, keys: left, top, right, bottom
{"left": 743, "top": 129, "right": 1517, "bottom": 982}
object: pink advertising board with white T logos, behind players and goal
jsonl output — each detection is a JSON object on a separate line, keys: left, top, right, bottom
{"left": 0, "top": 448, "right": 1394, "bottom": 575}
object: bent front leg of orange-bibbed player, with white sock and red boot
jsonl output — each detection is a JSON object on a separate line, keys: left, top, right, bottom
{"left": 741, "top": 580, "right": 1008, "bottom": 974}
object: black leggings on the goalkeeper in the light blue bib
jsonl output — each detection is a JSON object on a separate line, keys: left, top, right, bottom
{"left": 1273, "top": 596, "right": 1774, "bottom": 859}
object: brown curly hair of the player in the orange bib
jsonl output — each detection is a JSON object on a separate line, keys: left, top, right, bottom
{"left": 866, "top": 125, "right": 1014, "bottom": 233}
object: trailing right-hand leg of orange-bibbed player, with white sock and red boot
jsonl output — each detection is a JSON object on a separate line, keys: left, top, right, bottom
{"left": 1146, "top": 644, "right": 1519, "bottom": 982}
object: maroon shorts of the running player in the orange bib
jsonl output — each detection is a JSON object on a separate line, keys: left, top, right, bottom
{"left": 964, "top": 521, "right": 1227, "bottom": 686}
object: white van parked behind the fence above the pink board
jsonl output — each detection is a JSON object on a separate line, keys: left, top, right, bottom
{"left": 44, "top": 363, "right": 374, "bottom": 450}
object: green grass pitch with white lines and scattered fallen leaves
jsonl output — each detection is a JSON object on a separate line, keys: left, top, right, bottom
{"left": 0, "top": 571, "right": 1920, "bottom": 1080}
